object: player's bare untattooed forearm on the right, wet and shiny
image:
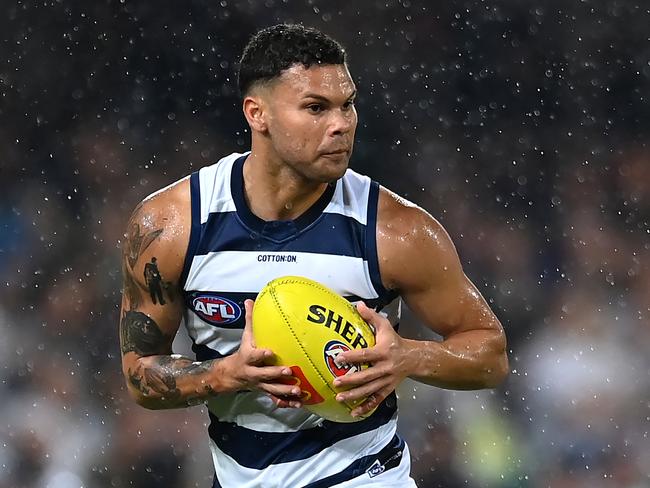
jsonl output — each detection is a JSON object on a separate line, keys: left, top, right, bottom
{"left": 408, "top": 330, "right": 508, "bottom": 390}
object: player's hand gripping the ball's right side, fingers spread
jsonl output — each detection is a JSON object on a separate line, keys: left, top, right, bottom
{"left": 334, "top": 302, "right": 413, "bottom": 417}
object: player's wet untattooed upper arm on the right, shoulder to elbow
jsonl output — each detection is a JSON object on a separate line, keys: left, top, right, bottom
{"left": 377, "top": 191, "right": 501, "bottom": 337}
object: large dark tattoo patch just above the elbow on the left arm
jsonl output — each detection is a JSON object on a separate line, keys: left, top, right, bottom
{"left": 120, "top": 310, "right": 169, "bottom": 356}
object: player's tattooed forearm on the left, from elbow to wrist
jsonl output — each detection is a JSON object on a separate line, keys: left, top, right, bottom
{"left": 125, "top": 355, "right": 221, "bottom": 409}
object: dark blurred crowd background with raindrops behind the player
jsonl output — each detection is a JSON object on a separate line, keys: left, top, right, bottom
{"left": 0, "top": 0, "right": 650, "bottom": 488}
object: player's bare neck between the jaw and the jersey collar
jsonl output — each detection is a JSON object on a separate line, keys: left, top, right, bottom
{"left": 244, "top": 150, "right": 327, "bottom": 220}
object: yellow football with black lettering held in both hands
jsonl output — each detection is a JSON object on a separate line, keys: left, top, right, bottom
{"left": 253, "top": 276, "right": 375, "bottom": 422}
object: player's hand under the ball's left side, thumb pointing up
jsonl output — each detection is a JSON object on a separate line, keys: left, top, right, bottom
{"left": 222, "top": 300, "right": 302, "bottom": 408}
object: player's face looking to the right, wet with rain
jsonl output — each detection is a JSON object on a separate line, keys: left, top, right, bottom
{"left": 260, "top": 65, "right": 357, "bottom": 182}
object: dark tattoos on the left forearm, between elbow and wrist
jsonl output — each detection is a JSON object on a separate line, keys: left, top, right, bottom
{"left": 128, "top": 356, "right": 216, "bottom": 405}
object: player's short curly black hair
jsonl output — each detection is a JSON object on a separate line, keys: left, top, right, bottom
{"left": 237, "top": 24, "right": 346, "bottom": 96}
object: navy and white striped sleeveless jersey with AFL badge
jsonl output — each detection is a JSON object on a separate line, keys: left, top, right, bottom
{"left": 181, "top": 153, "right": 414, "bottom": 488}
